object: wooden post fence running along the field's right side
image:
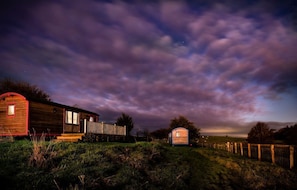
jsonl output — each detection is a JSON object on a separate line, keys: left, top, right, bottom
{"left": 203, "top": 142, "right": 297, "bottom": 169}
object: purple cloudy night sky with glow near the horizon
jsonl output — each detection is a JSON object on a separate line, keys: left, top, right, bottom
{"left": 0, "top": 0, "right": 297, "bottom": 135}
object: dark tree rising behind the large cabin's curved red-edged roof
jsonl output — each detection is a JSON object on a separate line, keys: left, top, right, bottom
{"left": 0, "top": 79, "right": 51, "bottom": 101}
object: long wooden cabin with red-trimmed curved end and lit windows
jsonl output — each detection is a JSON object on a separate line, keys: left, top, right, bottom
{"left": 0, "top": 92, "right": 99, "bottom": 136}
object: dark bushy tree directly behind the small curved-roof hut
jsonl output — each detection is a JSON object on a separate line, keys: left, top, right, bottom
{"left": 169, "top": 116, "right": 200, "bottom": 141}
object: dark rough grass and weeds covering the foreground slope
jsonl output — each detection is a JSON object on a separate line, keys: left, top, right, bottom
{"left": 0, "top": 141, "right": 297, "bottom": 189}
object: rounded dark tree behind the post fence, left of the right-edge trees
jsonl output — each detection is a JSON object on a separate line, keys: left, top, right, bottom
{"left": 247, "top": 122, "right": 274, "bottom": 144}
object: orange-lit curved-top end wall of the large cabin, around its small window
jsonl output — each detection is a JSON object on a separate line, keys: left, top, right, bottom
{"left": 0, "top": 95, "right": 28, "bottom": 136}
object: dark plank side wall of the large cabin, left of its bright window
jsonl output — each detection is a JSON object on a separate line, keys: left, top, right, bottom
{"left": 29, "top": 101, "right": 64, "bottom": 135}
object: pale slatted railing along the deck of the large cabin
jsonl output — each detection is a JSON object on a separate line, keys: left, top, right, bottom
{"left": 86, "top": 121, "right": 126, "bottom": 136}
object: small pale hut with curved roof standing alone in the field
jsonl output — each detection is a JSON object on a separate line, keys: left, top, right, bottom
{"left": 168, "top": 127, "right": 189, "bottom": 146}
